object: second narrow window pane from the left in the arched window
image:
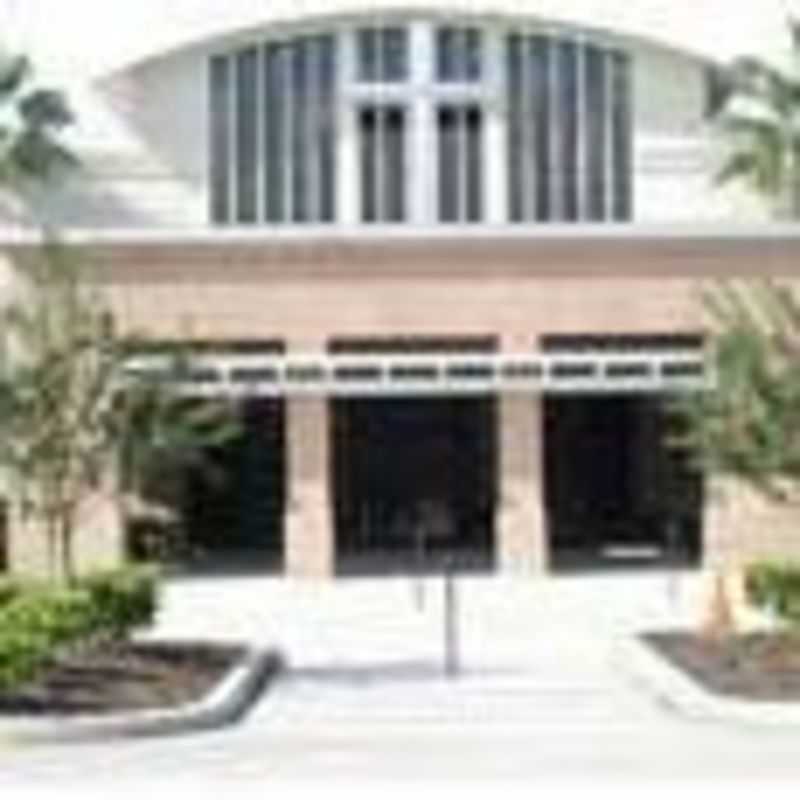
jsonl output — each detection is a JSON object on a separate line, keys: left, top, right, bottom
{"left": 236, "top": 47, "right": 258, "bottom": 223}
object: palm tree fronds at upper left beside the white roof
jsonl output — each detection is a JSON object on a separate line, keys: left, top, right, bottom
{"left": 0, "top": 55, "right": 77, "bottom": 189}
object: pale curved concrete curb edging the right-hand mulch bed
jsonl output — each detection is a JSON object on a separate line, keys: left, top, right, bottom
{"left": 615, "top": 638, "right": 800, "bottom": 727}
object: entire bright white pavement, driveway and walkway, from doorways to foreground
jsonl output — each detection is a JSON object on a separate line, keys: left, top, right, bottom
{"left": 0, "top": 574, "right": 800, "bottom": 786}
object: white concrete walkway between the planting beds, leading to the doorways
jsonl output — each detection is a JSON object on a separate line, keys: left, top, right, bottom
{"left": 147, "top": 573, "right": 700, "bottom": 734}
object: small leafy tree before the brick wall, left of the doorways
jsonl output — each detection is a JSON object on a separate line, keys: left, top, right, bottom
{"left": 0, "top": 242, "right": 235, "bottom": 580}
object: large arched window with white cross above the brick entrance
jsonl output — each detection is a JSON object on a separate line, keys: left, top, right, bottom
{"left": 208, "top": 19, "right": 633, "bottom": 225}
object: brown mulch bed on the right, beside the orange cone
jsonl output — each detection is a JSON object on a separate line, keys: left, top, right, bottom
{"left": 643, "top": 632, "right": 800, "bottom": 702}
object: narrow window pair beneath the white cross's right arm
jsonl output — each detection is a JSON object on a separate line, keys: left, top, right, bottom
{"left": 437, "top": 106, "right": 483, "bottom": 222}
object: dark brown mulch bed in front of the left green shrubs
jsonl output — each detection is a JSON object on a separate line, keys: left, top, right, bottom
{"left": 0, "top": 643, "right": 243, "bottom": 718}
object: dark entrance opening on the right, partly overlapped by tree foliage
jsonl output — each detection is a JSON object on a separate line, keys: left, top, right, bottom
{"left": 544, "top": 395, "right": 703, "bottom": 568}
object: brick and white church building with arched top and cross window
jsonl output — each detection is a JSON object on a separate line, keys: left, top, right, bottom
{"left": 0, "top": 0, "right": 800, "bottom": 577}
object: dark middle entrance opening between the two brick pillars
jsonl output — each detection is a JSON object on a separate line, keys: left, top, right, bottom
{"left": 332, "top": 397, "right": 496, "bottom": 574}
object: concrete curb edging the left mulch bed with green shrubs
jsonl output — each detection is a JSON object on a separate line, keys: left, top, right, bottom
{"left": 0, "top": 650, "right": 285, "bottom": 744}
